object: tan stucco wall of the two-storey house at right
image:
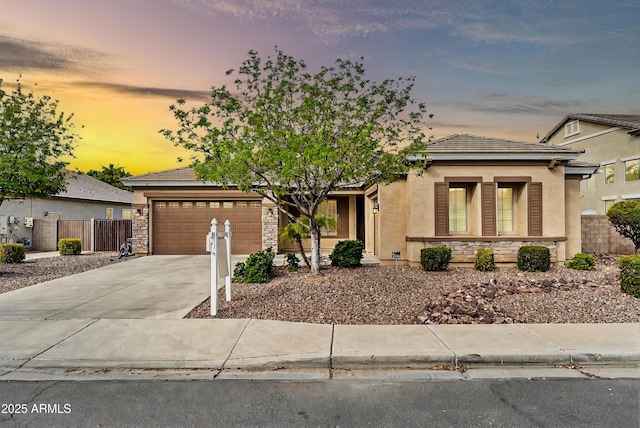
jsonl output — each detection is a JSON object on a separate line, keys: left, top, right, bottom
{"left": 548, "top": 121, "right": 640, "bottom": 214}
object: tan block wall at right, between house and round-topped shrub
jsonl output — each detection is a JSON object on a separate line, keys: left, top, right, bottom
{"left": 581, "top": 214, "right": 635, "bottom": 255}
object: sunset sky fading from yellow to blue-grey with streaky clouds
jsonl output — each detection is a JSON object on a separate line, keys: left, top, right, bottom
{"left": 0, "top": 0, "right": 640, "bottom": 175}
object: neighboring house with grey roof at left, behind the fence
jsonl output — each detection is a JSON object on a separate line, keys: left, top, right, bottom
{"left": 0, "top": 171, "right": 133, "bottom": 247}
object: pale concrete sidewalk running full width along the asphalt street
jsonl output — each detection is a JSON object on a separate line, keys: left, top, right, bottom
{"left": 0, "top": 319, "right": 640, "bottom": 380}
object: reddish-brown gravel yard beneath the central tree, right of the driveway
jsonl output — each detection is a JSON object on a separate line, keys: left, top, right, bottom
{"left": 187, "top": 257, "right": 640, "bottom": 324}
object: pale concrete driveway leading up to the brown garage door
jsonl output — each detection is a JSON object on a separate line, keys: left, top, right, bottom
{"left": 0, "top": 255, "right": 218, "bottom": 320}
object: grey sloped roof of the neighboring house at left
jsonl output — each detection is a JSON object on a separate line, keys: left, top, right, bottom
{"left": 55, "top": 171, "right": 133, "bottom": 204}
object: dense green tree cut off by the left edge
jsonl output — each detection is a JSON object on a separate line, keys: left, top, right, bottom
{"left": 0, "top": 79, "right": 80, "bottom": 204}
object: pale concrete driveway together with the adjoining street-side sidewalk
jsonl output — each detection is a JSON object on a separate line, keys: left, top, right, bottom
{"left": 0, "top": 256, "right": 640, "bottom": 380}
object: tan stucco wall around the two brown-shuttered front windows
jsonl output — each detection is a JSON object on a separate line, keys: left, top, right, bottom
{"left": 378, "top": 163, "right": 580, "bottom": 263}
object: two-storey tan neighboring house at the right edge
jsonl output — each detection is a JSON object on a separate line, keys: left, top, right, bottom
{"left": 542, "top": 114, "right": 640, "bottom": 214}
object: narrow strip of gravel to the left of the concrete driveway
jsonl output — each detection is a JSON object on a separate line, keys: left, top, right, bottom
{"left": 0, "top": 252, "right": 127, "bottom": 293}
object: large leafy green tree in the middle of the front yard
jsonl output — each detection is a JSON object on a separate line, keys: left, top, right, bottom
{"left": 160, "top": 48, "right": 427, "bottom": 274}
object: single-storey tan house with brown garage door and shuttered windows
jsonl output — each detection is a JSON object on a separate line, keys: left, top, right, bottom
{"left": 122, "top": 135, "right": 598, "bottom": 264}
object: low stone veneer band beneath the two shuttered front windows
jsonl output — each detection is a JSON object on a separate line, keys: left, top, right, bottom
{"left": 425, "top": 240, "right": 558, "bottom": 263}
